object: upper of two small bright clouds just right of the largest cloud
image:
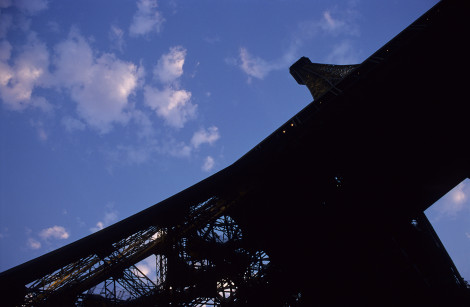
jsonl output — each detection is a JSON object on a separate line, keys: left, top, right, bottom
{"left": 153, "top": 46, "right": 186, "bottom": 83}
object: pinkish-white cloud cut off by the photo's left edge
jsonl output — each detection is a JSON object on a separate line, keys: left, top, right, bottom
{"left": 0, "top": 33, "right": 51, "bottom": 111}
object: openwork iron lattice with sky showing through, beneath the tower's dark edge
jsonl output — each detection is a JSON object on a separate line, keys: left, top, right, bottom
{"left": 22, "top": 197, "right": 270, "bottom": 306}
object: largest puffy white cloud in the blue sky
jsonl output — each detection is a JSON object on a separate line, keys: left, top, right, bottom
{"left": 54, "top": 30, "right": 142, "bottom": 133}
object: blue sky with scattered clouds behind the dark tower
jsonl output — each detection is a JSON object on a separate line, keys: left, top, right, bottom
{"left": 0, "top": 0, "right": 470, "bottom": 279}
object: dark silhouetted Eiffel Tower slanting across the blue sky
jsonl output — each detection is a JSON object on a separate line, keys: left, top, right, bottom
{"left": 0, "top": 1, "right": 470, "bottom": 306}
